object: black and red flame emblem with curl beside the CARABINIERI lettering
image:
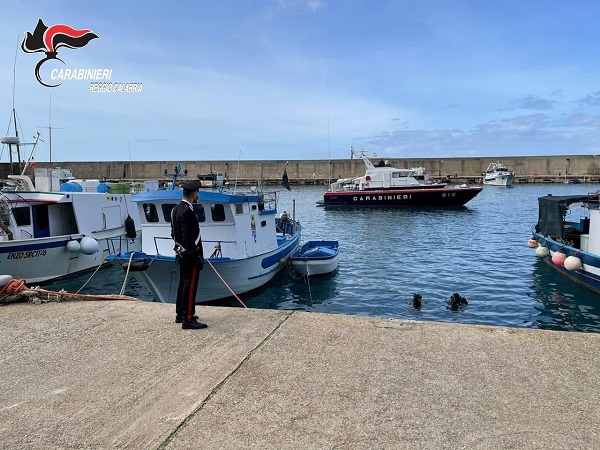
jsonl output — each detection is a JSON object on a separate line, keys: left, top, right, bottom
{"left": 21, "top": 19, "right": 99, "bottom": 87}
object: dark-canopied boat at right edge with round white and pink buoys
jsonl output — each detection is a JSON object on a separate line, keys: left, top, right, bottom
{"left": 529, "top": 193, "right": 600, "bottom": 293}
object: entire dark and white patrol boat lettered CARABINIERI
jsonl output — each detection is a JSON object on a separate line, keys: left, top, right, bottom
{"left": 317, "top": 152, "right": 482, "bottom": 207}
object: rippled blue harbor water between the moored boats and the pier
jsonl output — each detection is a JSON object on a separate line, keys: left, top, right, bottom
{"left": 48, "top": 184, "right": 600, "bottom": 333}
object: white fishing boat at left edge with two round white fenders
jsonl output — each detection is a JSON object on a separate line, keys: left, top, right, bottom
{"left": 0, "top": 175, "right": 141, "bottom": 283}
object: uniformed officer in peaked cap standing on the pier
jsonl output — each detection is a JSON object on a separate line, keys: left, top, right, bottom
{"left": 171, "top": 180, "right": 206, "bottom": 329}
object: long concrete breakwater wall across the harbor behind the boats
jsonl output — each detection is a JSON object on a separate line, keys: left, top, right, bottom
{"left": 0, "top": 155, "right": 600, "bottom": 185}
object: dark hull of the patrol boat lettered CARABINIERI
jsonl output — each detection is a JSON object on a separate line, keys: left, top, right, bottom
{"left": 318, "top": 186, "right": 483, "bottom": 207}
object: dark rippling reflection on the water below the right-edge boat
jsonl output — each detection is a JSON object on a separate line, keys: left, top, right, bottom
{"left": 529, "top": 260, "right": 600, "bottom": 333}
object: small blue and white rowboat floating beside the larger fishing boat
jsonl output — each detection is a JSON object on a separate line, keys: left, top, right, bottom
{"left": 290, "top": 240, "right": 340, "bottom": 276}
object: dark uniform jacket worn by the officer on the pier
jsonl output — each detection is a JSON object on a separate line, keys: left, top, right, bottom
{"left": 171, "top": 201, "right": 204, "bottom": 264}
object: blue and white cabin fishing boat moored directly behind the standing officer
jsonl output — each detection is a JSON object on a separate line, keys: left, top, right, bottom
{"left": 107, "top": 189, "right": 301, "bottom": 303}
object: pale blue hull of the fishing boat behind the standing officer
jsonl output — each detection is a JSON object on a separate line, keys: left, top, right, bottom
{"left": 109, "top": 232, "right": 300, "bottom": 303}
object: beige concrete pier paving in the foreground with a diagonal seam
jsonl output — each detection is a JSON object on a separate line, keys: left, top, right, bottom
{"left": 0, "top": 302, "right": 600, "bottom": 449}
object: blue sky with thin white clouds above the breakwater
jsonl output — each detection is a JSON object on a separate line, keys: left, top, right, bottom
{"left": 0, "top": 0, "right": 600, "bottom": 162}
